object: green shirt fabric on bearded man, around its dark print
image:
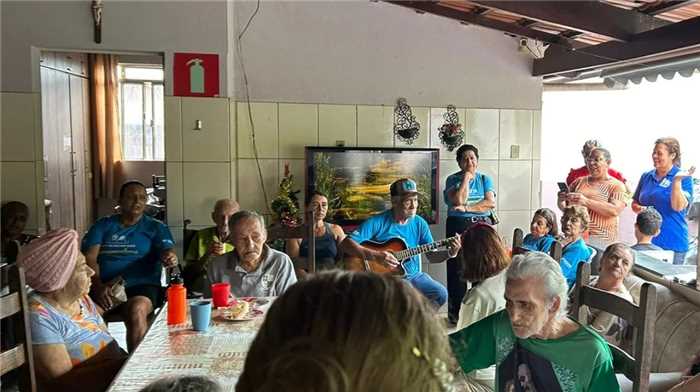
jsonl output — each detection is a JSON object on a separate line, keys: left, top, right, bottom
{"left": 449, "top": 310, "right": 620, "bottom": 392}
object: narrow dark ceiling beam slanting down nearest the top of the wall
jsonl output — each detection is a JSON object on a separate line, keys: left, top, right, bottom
{"left": 386, "top": 1, "right": 580, "bottom": 48}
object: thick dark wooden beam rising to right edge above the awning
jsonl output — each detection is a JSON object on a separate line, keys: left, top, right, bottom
{"left": 532, "top": 16, "right": 700, "bottom": 76}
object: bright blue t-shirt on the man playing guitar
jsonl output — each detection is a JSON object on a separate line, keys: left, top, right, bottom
{"left": 350, "top": 210, "right": 433, "bottom": 279}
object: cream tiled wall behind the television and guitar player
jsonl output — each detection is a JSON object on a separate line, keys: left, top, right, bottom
{"left": 161, "top": 97, "right": 540, "bottom": 272}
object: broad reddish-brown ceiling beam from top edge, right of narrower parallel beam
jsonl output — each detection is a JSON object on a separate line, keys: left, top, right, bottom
{"left": 470, "top": 0, "right": 669, "bottom": 41}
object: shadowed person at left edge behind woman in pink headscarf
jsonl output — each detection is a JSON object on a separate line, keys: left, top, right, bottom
{"left": 0, "top": 201, "right": 36, "bottom": 263}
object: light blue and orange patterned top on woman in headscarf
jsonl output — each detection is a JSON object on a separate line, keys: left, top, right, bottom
{"left": 29, "top": 293, "right": 114, "bottom": 366}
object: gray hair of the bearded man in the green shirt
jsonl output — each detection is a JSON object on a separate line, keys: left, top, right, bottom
{"left": 506, "top": 252, "right": 569, "bottom": 319}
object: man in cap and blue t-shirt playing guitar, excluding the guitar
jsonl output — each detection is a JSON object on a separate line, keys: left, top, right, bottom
{"left": 340, "top": 178, "right": 461, "bottom": 307}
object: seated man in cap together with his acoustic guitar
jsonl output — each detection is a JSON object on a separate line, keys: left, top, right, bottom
{"left": 340, "top": 178, "right": 461, "bottom": 307}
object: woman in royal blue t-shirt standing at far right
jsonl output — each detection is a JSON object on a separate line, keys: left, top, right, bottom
{"left": 632, "top": 137, "right": 695, "bottom": 264}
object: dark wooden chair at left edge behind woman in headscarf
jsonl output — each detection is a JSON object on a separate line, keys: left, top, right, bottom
{"left": 0, "top": 264, "right": 37, "bottom": 392}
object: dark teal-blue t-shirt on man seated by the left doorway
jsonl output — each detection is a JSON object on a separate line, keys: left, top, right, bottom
{"left": 81, "top": 214, "right": 175, "bottom": 287}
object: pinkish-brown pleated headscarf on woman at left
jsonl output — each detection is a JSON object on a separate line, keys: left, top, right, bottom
{"left": 17, "top": 228, "right": 79, "bottom": 293}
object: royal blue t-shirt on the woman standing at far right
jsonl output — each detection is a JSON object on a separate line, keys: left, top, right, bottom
{"left": 632, "top": 166, "right": 693, "bottom": 252}
